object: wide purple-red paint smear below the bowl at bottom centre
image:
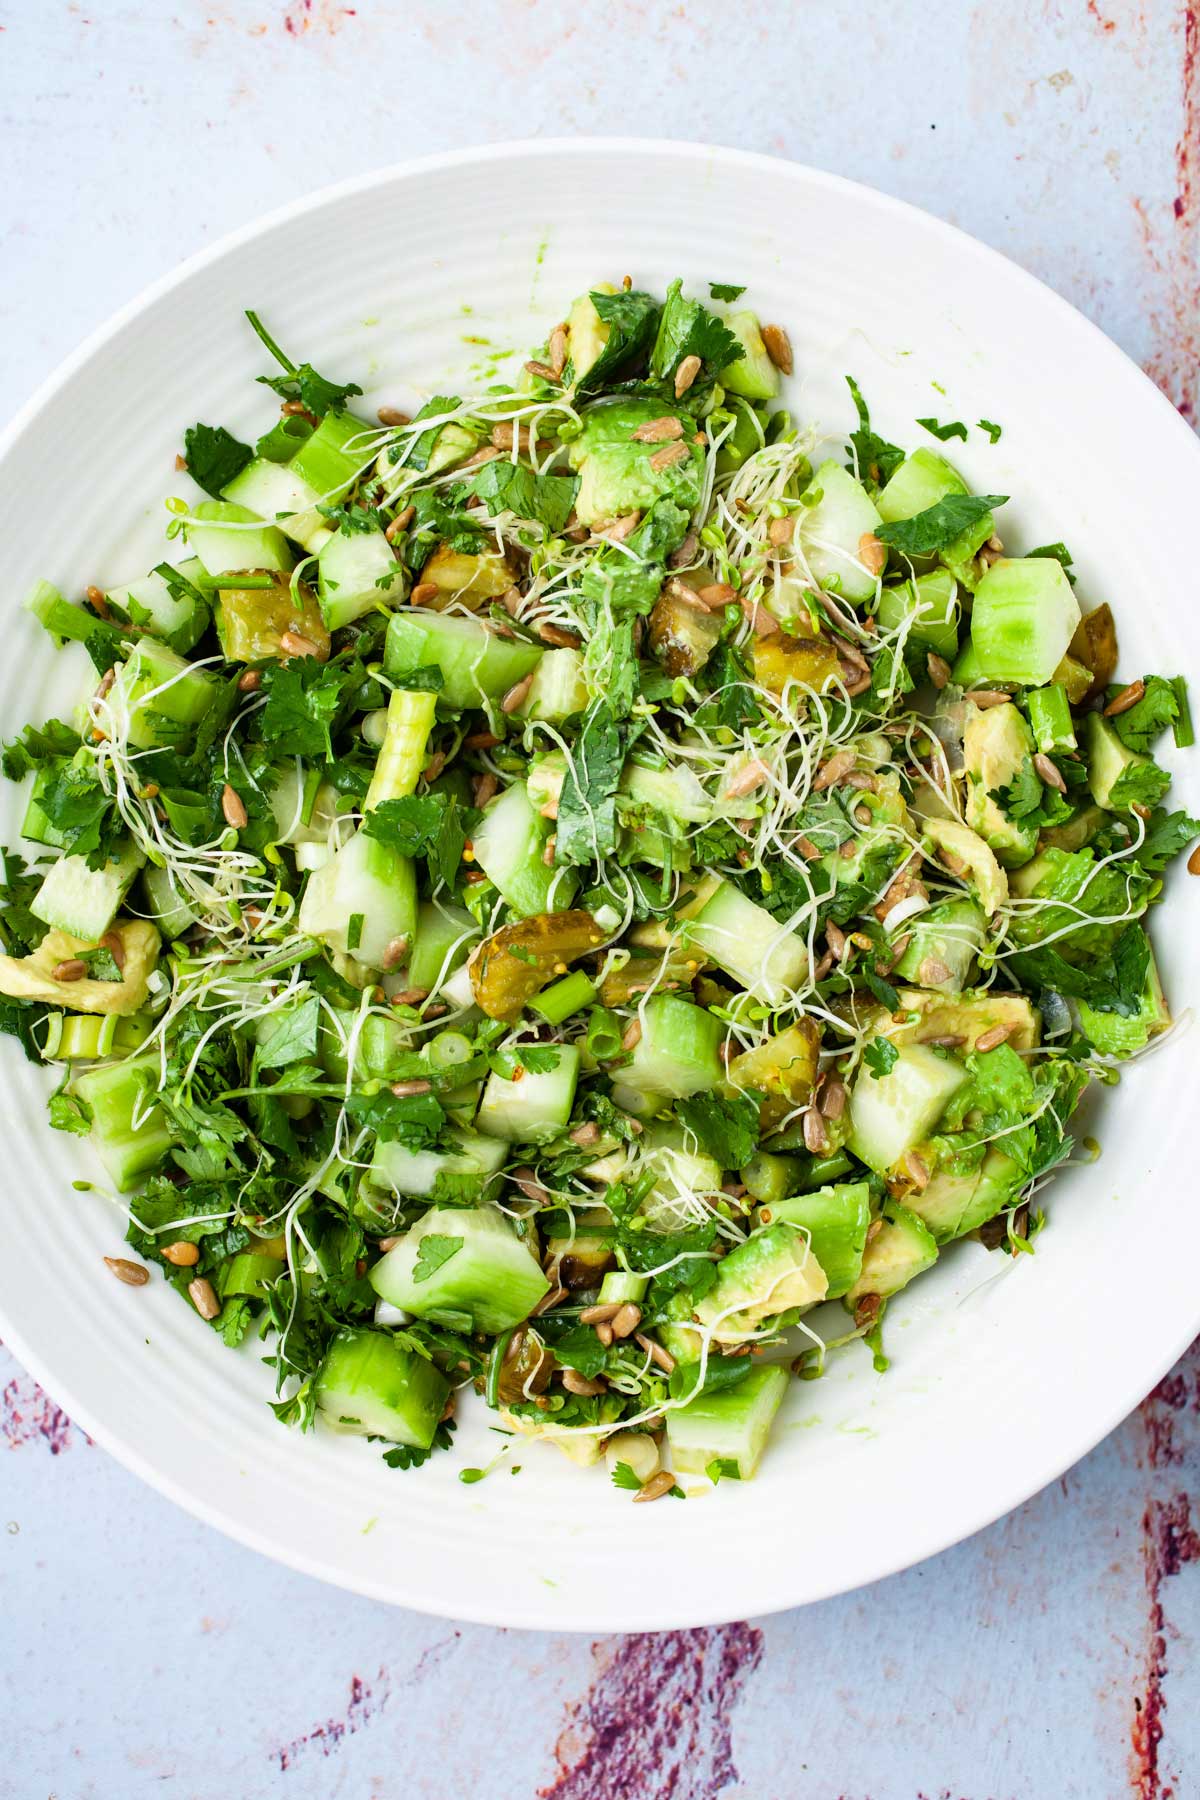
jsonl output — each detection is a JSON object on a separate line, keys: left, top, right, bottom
{"left": 538, "top": 1624, "right": 763, "bottom": 1800}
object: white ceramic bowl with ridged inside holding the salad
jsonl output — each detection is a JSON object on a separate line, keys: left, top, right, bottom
{"left": 0, "top": 140, "right": 1200, "bottom": 1631}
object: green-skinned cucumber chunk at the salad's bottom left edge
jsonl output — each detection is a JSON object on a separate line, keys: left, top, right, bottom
{"left": 317, "top": 1327, "right": 450, "bottom": 1451}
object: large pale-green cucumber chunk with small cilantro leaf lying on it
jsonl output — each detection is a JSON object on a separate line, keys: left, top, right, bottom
{"left": 369, "top": 1206, "right": 551, "bottom": 1332}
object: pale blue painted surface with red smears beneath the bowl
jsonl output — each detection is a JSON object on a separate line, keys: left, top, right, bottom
{"left": 0, "top": 0, "right": 1200, "bottom": 1800}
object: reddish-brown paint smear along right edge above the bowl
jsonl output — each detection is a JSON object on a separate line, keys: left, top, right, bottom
{"left": 1133, "top": 4, "right": 1200, "bottom": 423}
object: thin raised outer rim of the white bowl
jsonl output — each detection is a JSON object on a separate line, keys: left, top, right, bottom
{"left": 0, "top": 135, "right": 1200, "bottom": 1631}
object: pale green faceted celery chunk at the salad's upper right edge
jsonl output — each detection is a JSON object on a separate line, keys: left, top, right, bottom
{"left": 972, "top": 556, "right": 1079, "bottom": 688}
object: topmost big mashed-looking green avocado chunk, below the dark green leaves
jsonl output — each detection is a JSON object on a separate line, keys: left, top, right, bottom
{"left": 570, "top": 400, "right": 703, "bottom": 526}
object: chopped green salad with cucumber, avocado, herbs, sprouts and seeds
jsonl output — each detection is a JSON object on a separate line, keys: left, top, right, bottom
{"left": 0, "top": 281, "right": 1200, "bottom": 1499}
